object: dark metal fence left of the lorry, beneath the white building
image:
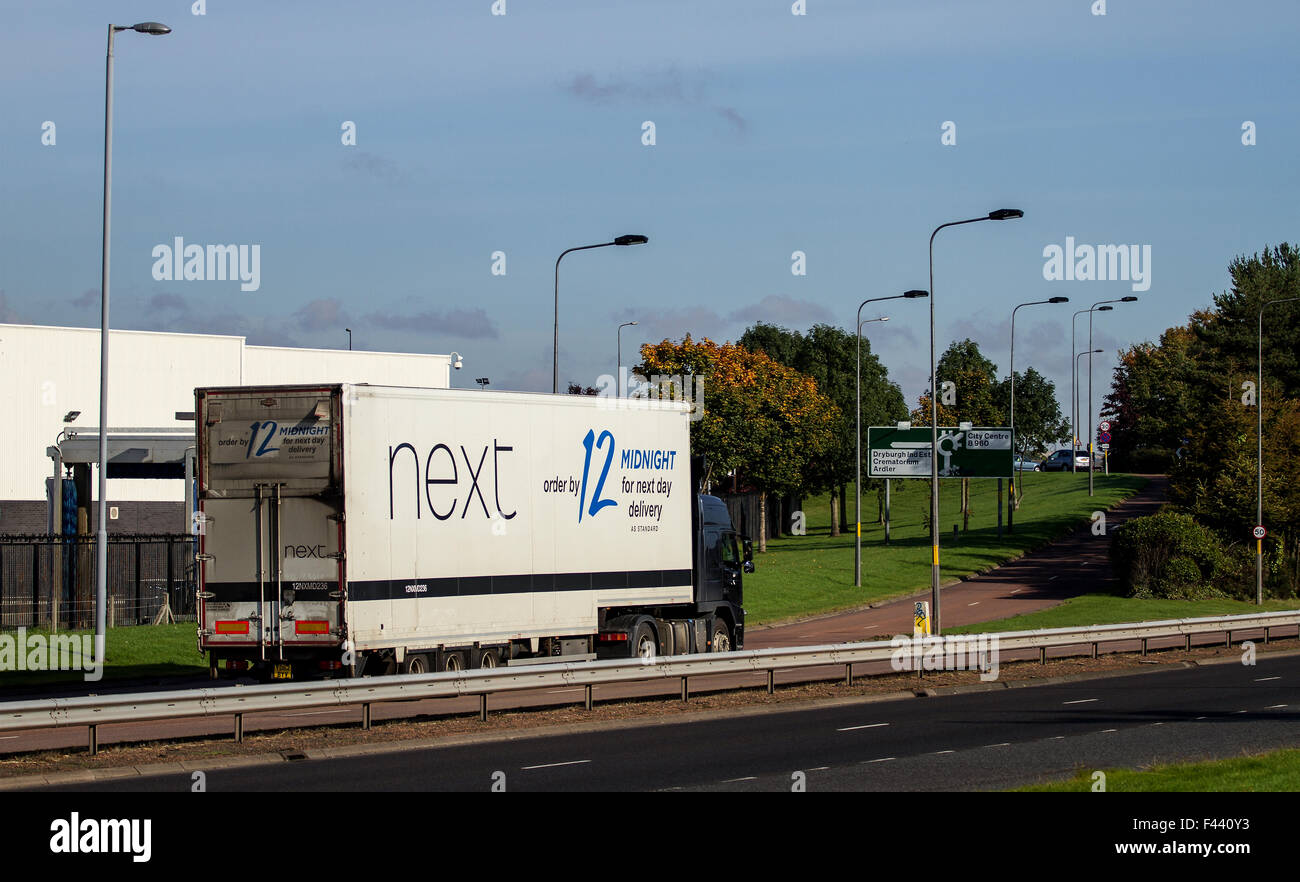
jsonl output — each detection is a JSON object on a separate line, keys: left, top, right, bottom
{"left": 0, "top": 533, "right": 195, "bottom": 630}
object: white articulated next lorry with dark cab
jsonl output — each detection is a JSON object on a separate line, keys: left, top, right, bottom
{"left": 195, "top": 384, "right": 753, "bottom": 679}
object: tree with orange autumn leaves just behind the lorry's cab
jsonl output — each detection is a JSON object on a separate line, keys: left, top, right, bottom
{"left": 637, "top": 334, "right": 840, "bottom": 552}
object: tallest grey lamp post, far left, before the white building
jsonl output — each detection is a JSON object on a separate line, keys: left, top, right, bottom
{"left": 95, "top": 21, "right": 172, "bottom": 663}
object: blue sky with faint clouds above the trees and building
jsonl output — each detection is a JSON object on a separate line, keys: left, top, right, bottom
{"left": 0, "top": 0, "right": 1300, "bottom": 429}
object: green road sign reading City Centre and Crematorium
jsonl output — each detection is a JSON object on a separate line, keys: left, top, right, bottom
{"left": 867, "top": 425, "right": 1013, "bottom": 477}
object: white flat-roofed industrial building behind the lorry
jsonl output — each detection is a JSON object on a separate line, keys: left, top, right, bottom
{"left": 0, "top": 324, "right": 451, "bottom": 533}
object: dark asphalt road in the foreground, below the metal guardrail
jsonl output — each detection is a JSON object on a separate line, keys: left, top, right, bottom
{"left": 40, "top": 654, "right": 1300, "bottom": 792}
